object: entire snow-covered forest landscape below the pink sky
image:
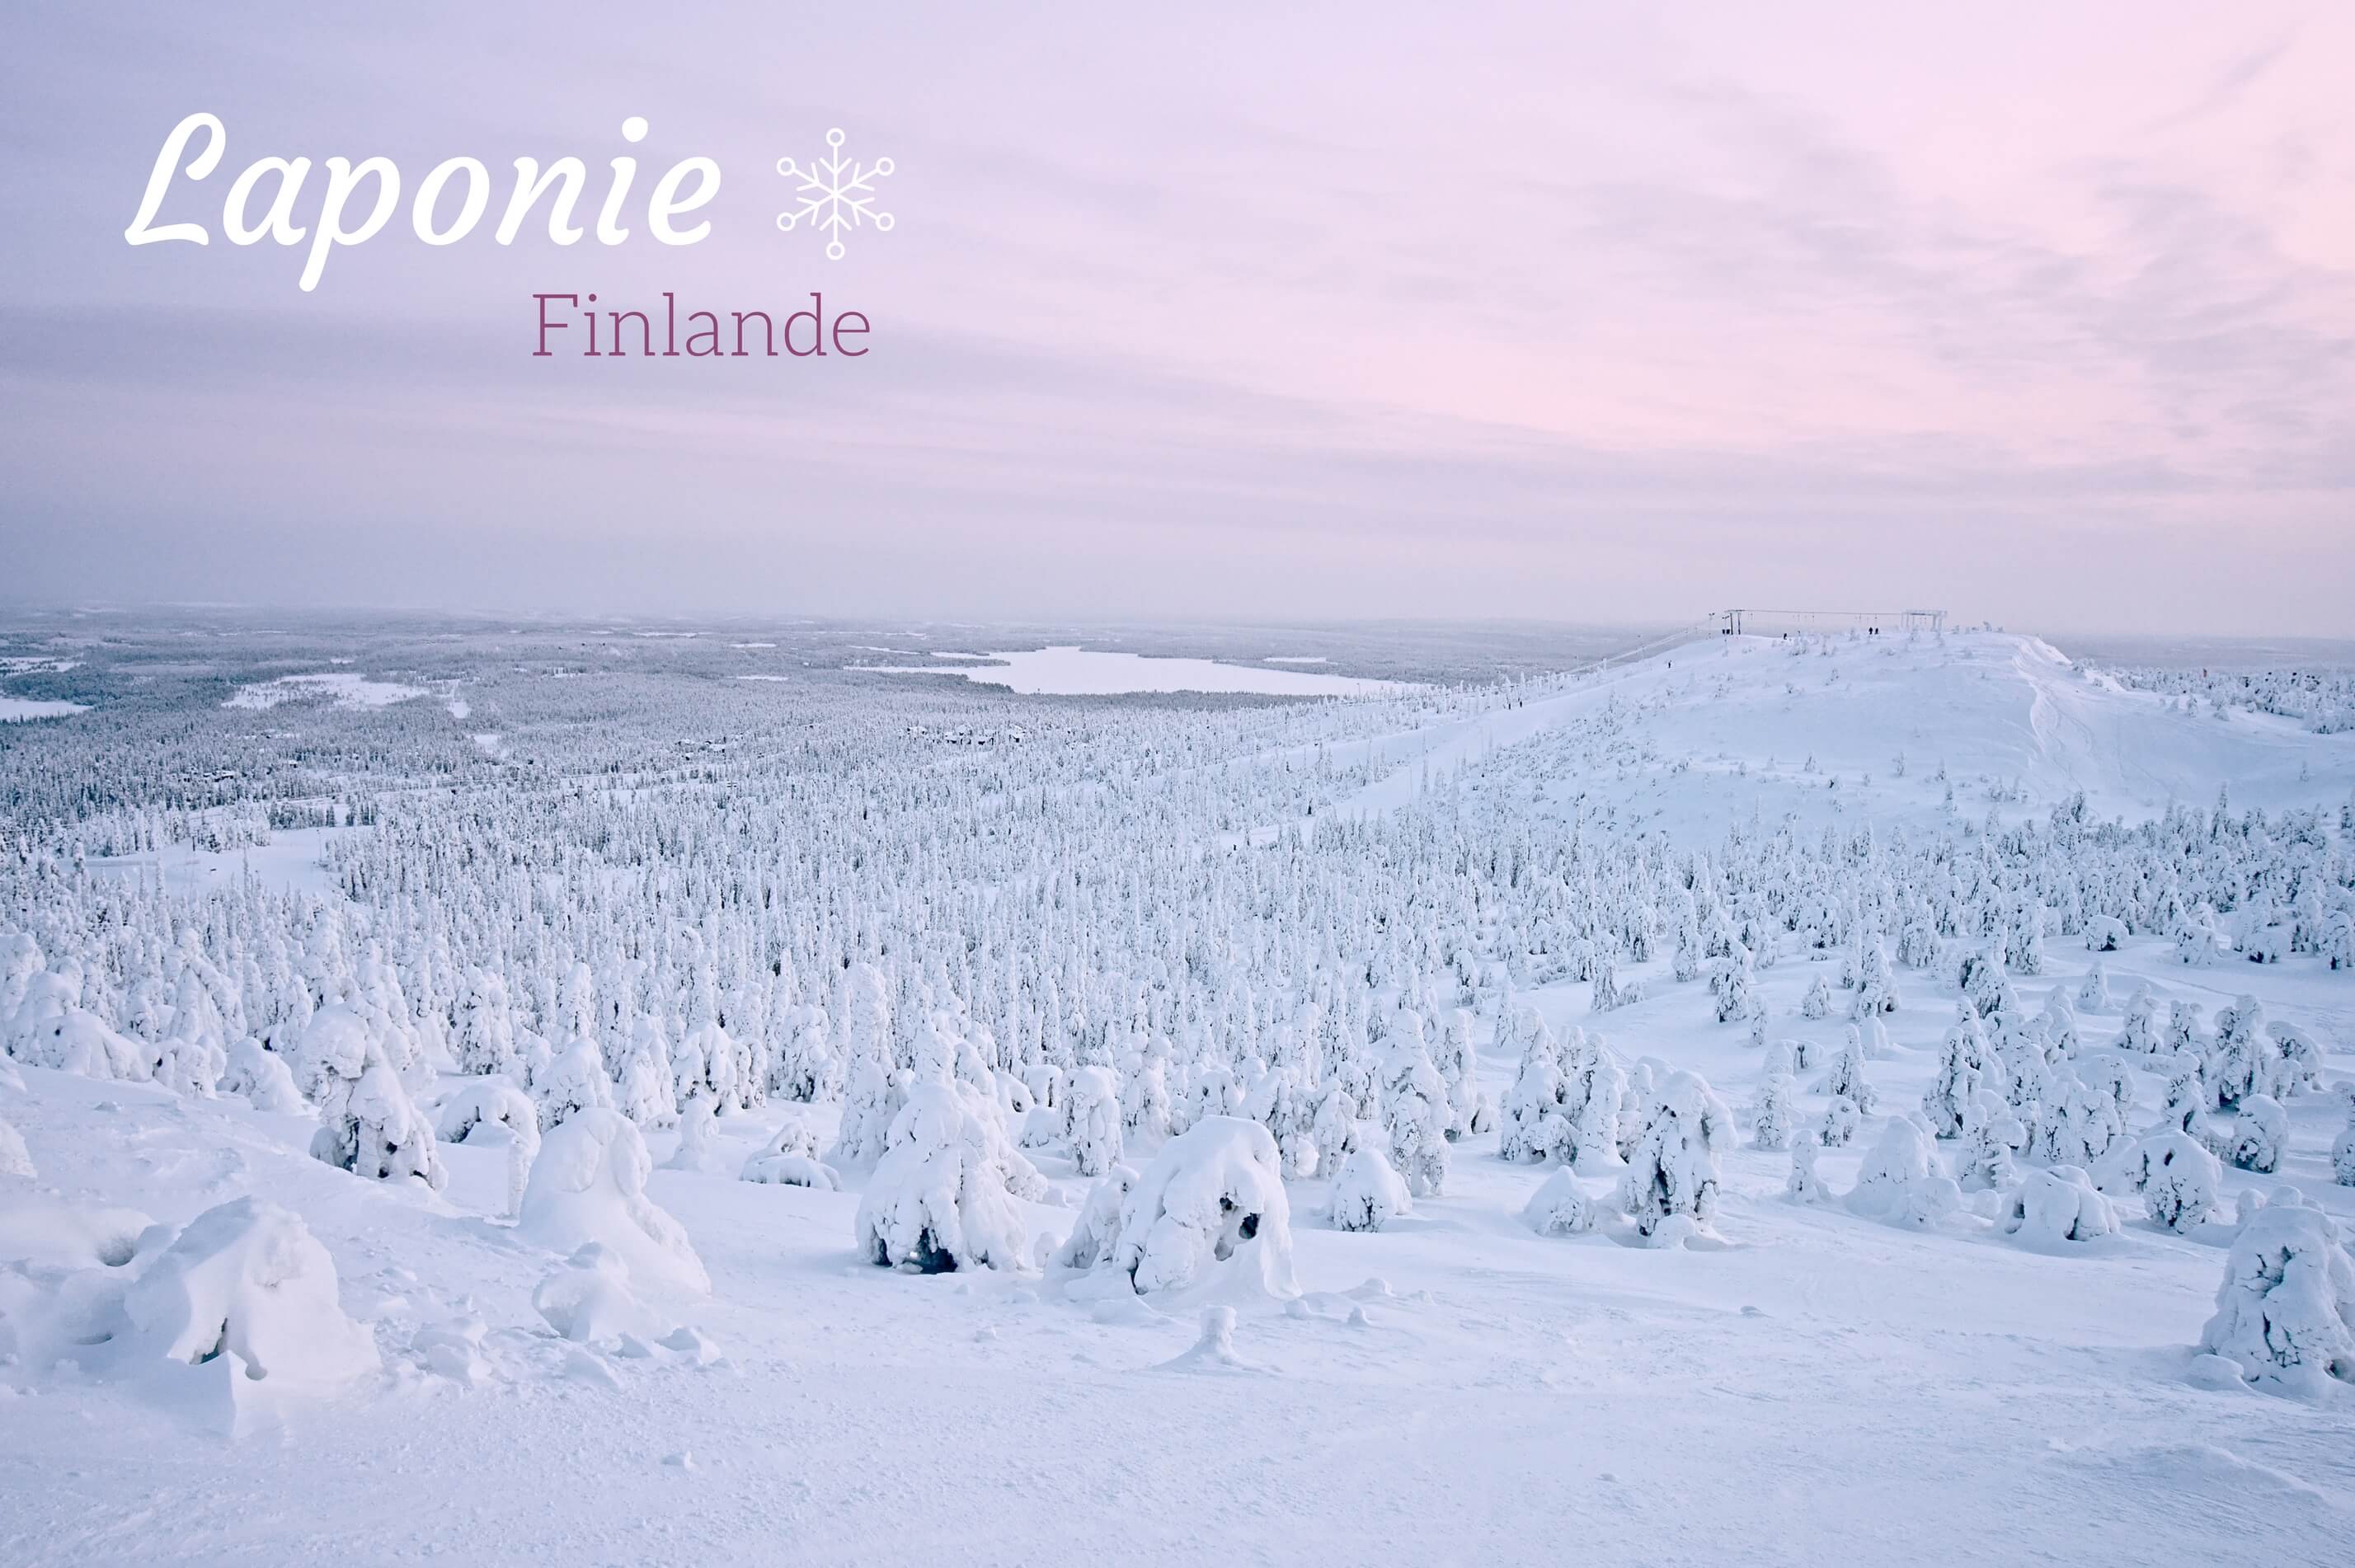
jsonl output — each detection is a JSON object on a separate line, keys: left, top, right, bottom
{"left": 0, "top": 614, "right": 2355, "bottom": 1563}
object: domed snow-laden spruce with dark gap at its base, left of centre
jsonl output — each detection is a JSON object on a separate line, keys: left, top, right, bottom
{"left": 855, "top": 1081, "right": 1046, "bottom": 1274}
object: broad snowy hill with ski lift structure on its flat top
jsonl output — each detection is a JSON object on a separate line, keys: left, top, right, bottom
{"left": 1351, "top": 631, "right": 2355, "bottom": 831}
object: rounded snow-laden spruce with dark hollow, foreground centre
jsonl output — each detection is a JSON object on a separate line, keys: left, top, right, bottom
{"left": 1104, "top": 1116, "right": 1300, "bottom": 1298}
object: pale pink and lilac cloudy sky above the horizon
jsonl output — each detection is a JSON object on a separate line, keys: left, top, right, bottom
{"left": 0, "top": 5, "right": 2355, "bottom": 633}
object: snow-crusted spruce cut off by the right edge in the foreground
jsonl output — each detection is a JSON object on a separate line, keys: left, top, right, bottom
{"left": 2200, "top": 1203, "right": 2355, "bottom": 1394}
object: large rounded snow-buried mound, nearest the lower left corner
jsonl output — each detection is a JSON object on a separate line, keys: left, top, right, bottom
{"left": 123, "top": 1199, "right": 377, "bottom": 1392}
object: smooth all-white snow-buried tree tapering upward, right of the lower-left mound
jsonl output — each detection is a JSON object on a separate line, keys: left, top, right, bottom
{"left": 529, "top": 1109, "right": 712, "bottom": 1295}
